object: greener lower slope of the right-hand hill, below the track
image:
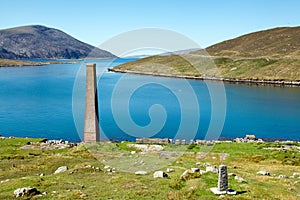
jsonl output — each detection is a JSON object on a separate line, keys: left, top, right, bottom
{"left": 115, "top": 54, "right": 300, "bottom": 81}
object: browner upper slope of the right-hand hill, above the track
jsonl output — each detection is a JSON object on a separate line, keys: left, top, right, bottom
{"left": 202, "top": 26, "right": 300, "bottom": 58}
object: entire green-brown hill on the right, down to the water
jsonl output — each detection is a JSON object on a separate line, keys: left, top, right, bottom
{"left": 112, "top": 27, "right": 300, "bottom": 84}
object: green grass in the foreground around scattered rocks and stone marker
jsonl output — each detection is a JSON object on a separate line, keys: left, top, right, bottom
{"left": 0, "top": 138, "right": 300, "bottom": 200}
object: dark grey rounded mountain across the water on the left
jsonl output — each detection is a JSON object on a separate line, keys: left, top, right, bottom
{"left": 0, "top": 25, "right": 115, "bottom": 59}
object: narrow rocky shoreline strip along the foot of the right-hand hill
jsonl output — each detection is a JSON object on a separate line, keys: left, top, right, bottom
{"left": 108, "top": 68, "right": 300, "bottom": 87}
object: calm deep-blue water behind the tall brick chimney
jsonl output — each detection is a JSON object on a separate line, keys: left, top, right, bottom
{"left": 0, "top": 59, "right": 300, "bottom": 141}
